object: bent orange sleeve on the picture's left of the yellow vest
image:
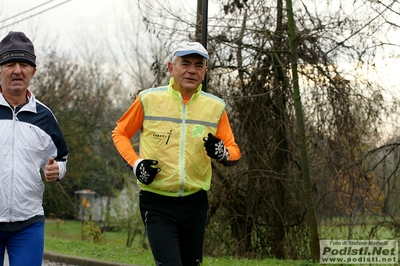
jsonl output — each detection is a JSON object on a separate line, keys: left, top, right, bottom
{"left": 111, "top": 97, "right": 144, "bottom": 167}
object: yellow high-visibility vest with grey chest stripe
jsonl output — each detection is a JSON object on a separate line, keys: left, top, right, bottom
{"left": 138, "top": 78, "right": 225, "bottom": 196}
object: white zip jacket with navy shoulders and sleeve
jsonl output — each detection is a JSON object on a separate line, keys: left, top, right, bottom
{"left": 0, "top": 91, "right": 68, "bottom": 222}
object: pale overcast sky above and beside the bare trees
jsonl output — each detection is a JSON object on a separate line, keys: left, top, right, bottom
{"left": 0, "top": 0, "right": 399, "bottom": 93}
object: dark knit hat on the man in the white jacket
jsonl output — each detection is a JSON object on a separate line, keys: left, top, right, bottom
{"left": 0, "top": 31, "right": 36, "bottom": 67}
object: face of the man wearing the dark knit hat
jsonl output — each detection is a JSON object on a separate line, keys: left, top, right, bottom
{"left": 0, "top": 62, "right": 36, "bottom": 95}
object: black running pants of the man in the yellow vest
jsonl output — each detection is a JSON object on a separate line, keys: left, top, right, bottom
{"left": 139, "top": 190, "right": 208, "bottom": 266}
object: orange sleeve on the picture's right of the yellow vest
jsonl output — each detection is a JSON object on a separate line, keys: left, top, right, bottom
{"left": 215, "top": 111, "right": 241, "bottom": 161}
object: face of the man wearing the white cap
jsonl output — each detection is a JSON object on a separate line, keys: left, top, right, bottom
{"left": 168, "top": 54, "right": 207, "bottom": 92}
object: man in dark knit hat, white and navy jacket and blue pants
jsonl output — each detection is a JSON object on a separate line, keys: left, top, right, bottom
{"left": 0, "top": 31, "right": 68, "bottom": 266}
